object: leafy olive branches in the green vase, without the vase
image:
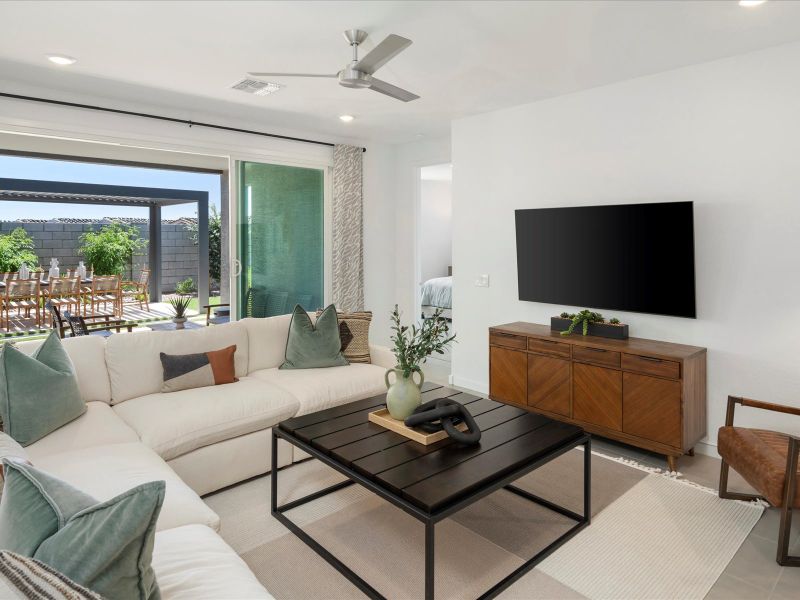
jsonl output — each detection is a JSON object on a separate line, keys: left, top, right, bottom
{"left": 391, "top": 304, "right": 456, "bottom": 377}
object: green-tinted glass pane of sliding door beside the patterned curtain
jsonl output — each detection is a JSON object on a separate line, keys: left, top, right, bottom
{"left": 239, "top": 162, "right": 324, "bottom": 317}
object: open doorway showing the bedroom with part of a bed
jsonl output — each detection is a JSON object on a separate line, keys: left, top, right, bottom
{"left": 417, "top": 163, "right": 453, "bottom": 382}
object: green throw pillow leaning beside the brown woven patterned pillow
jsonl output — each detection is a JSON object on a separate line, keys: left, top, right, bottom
{"left": 281, "top": 304, "right": 350, "bottom": 369}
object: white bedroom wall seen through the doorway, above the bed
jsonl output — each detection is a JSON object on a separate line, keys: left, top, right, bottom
{"left": 419, "top": 179, "right": 453, "bottom": 281}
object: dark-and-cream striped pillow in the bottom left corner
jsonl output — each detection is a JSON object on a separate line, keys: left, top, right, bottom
{"left": 0, "top": 551, "right": 103, "bottom": 600}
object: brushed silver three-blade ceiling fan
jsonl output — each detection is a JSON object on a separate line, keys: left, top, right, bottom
{"left": 248, "top": 29, "right": 419, "bottom": 102}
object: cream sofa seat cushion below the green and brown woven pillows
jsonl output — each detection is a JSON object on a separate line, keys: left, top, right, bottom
{"left": 251, "top": 363, "right": 386, "bottom": 415}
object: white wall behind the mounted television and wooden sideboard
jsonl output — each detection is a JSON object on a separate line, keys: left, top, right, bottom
{"left": 452, "top": 44, "right": 800, "bottom": 444}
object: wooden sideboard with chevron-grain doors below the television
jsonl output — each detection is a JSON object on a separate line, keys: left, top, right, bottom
{"left": 489, "top": 322, "right": 706, "bottom": 470}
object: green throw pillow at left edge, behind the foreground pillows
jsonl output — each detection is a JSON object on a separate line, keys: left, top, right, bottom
{"left": 0, "top": 331, "right": 86, "bottom": 446}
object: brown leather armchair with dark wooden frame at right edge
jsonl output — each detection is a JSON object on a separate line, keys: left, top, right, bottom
{"left": 717, "top": 396, "right": 800, "bottom": 567}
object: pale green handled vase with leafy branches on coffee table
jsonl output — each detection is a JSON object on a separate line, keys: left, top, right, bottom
{"left": 385, "top": 304, "right": 456, "bottom": 420}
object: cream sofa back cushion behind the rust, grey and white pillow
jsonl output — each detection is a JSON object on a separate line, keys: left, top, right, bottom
{"left": 106, "top": 323, "right": 248, "bottom": 405}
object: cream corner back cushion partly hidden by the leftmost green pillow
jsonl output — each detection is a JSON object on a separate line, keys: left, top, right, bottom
{"left": 15, "top": 335, "right": 111, "bottom": 403}
